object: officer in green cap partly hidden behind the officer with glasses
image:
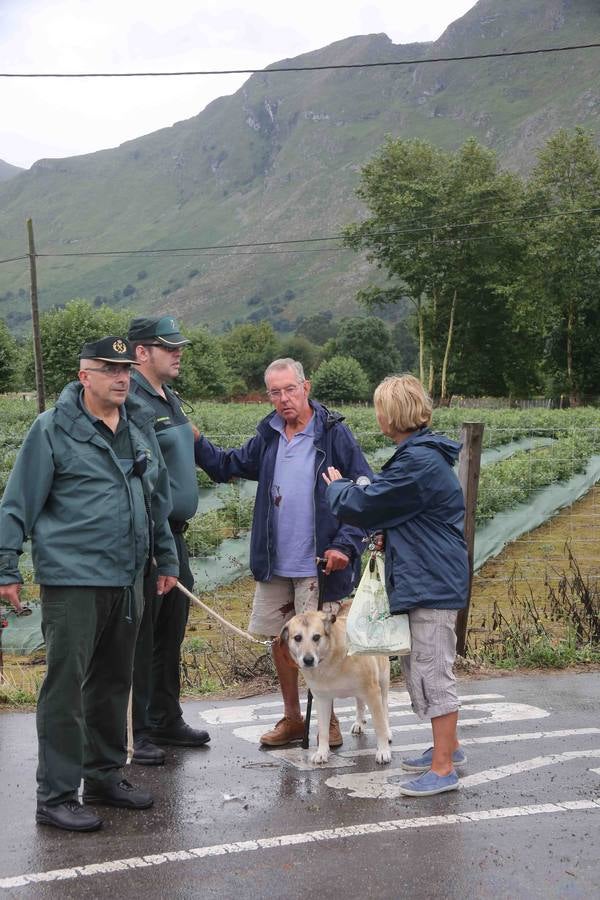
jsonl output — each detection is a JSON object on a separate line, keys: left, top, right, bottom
{"left": 128, "top": 316, "right": 210, "bottom": 765}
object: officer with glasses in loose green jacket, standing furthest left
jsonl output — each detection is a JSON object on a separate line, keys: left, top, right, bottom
{"left": 0, "top": 336, "right": 179, "bottom": 831}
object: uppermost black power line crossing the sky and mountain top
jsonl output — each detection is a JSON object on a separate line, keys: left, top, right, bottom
{"left": 0, "top": 42, "right": 600, "bottom": 78}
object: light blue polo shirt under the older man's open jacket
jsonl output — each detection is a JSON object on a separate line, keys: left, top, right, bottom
{"left": 270, "top": 413, "right": 317, "bottom": 578}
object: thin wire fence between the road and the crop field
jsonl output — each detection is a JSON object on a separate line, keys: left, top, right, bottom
{"left": 5, "top": 420, "right": 600, "bottom": 692}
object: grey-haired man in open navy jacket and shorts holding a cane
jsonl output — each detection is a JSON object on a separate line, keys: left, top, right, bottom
{"left": 195, "top": 359, "right": 372, "bottom": 747}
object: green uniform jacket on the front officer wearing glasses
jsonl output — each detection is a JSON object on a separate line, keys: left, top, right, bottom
{"left": 0, "top": 382, "right": 179, "bottom": 587}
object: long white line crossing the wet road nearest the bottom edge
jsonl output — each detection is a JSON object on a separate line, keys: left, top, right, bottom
{"left": 0, "top": 800, "right": 600, "bottom": 890}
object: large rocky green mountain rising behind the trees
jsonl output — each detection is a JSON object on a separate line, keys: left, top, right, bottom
{"left": 0, "top": 0, "right": 600, "bottom": 329}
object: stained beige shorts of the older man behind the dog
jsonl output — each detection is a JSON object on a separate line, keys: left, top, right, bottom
{"left": 248, "top": 575, "right": 340, "bottom": 637}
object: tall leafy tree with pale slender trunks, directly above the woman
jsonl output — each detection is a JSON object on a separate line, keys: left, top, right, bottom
{"left": 346, "top": 138, "right": 523, "bottom": 398}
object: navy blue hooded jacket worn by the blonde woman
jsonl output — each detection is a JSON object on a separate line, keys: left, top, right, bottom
{"left": 327, "top": 428, "right": 469, "bottom": 612}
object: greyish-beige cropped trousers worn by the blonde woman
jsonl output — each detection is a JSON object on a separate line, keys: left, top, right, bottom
{"left": 400, "top": 606, "right": 460, "bottom": 719}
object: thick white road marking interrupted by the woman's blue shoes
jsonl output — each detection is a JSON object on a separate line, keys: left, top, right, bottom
{"left": 325, "top": 748, "right": 600, "bottom": 800}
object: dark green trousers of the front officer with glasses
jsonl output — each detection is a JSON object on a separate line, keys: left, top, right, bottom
{"left": 37, "top": 578, "right": 143, "bottom": 805}
